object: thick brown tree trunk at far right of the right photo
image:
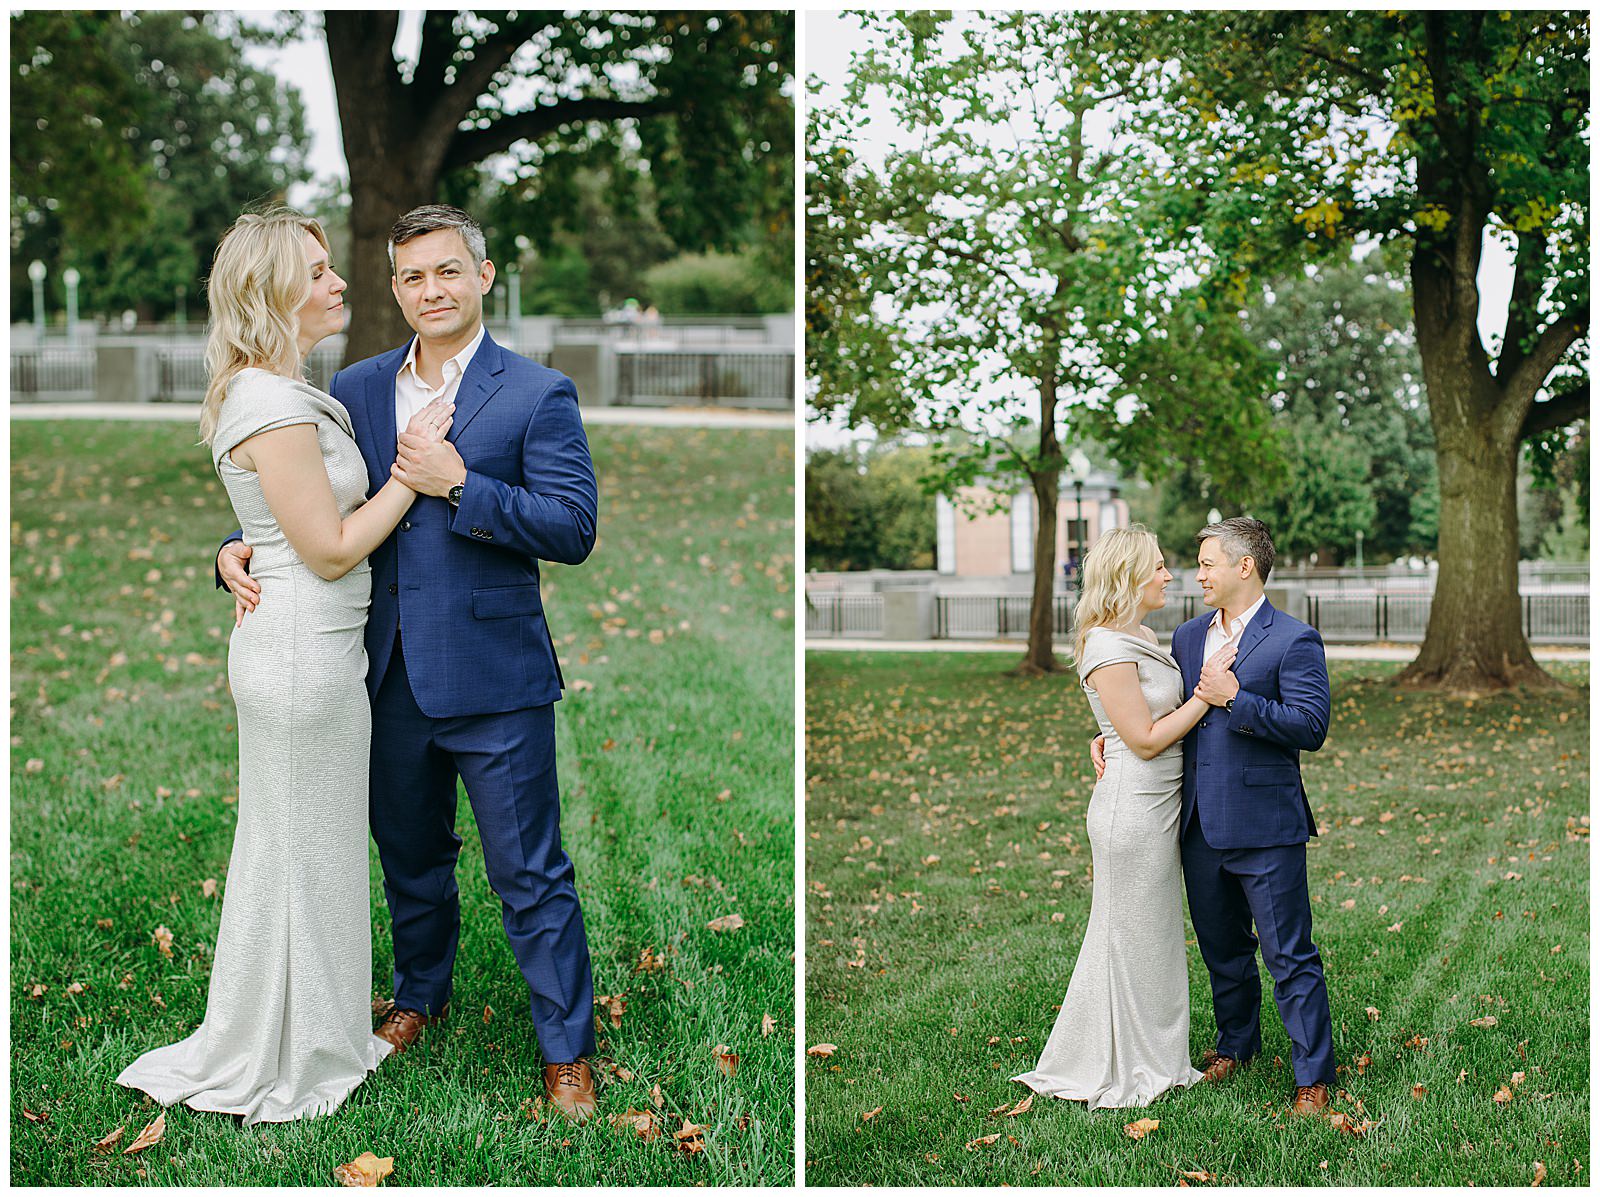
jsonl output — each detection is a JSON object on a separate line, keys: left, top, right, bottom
{"left": 1395, "top": 245, "right": 1560, "bottom": 693}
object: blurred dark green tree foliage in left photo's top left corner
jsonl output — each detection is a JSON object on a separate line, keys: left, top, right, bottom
{"left": 11, "top": 10, "right": 307, "bottom": 318}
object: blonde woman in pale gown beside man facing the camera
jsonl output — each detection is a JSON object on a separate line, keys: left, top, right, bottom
{"left": 117, "top": 210, "right": 451, "bottom": 1123}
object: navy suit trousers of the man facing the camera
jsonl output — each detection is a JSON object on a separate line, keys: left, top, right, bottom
{"left": 370, "top": 642, "right": 595, "bottom": 1064}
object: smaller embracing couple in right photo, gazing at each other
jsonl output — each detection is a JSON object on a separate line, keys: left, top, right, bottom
{"left": 1016, "top": 518, "right": 1334, "bottom": 1115}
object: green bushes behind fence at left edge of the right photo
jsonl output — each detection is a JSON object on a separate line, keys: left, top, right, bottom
{"left": 805, "top": 445, "right": 938, "bottom": 570}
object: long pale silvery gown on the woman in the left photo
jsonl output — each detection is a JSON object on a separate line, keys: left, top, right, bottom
{"left": 117, "top": 370, "right": 390, "bottom": 1123}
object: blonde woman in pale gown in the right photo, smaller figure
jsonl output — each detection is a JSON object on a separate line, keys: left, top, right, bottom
{"left": 1013, "top": 526, "right": 1210, "bottom": 1111}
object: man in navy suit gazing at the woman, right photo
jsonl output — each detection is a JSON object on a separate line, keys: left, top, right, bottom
{"left": 1091, "top": 517, "right": 1334, "bottom": 1115}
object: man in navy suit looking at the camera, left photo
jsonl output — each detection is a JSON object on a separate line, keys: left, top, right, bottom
{"left": 218, "top": 205, "right": 598, "bottom": 1122}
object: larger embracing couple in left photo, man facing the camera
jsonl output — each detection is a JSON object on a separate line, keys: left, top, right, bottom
{"left": 117, "top": 205, "right": 598, "bottom": 1123}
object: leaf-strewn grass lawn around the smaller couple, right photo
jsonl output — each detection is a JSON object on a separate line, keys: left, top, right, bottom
{"left": 805, "top": 651, "right": 1589, "bottom": 1186}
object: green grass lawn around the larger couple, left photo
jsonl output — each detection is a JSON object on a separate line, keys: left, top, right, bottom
{"left": 10, "top": 421, "right": 795, "bottom": 1186}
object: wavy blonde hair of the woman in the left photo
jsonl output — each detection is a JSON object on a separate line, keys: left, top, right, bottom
{"left": 200, "top": 208, "right": 328, "bottom": 445}
